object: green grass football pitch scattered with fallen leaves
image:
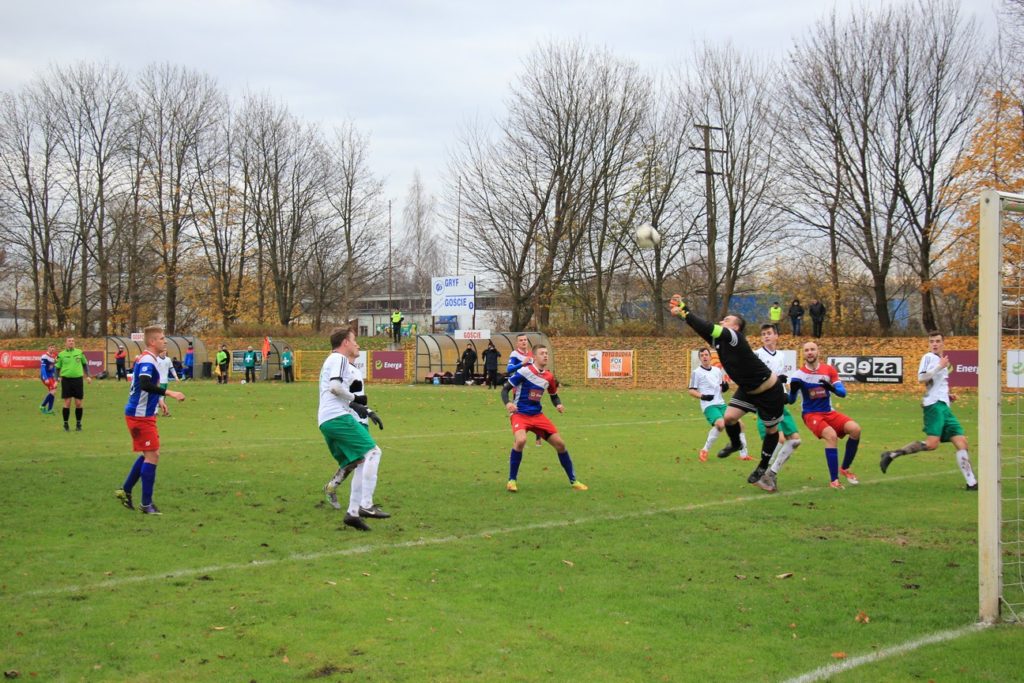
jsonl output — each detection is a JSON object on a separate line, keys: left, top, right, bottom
{"left": 0, "top": 380, "right": 1024, "bottom": 681}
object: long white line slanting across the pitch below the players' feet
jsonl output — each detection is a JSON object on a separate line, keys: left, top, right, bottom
{"left": 9, "top": 470, "right": 953, "bottom": 598}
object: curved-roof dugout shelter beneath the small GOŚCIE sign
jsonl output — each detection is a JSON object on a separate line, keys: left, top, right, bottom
{"left": 415, "top": 332, "right": 555, "bottom": 384}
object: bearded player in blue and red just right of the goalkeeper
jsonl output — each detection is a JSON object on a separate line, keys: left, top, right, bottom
{"left": 790, "top": 342, "right": 860, "bottom": 488}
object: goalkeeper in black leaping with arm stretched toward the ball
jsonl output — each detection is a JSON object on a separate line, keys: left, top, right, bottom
{"left": 669, "top": 294, "right": 785, "bottom": 483}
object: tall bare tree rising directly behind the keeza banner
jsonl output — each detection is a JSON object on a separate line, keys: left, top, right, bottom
{"left": 787, "top": 10, "right": 907, "bottom": 333}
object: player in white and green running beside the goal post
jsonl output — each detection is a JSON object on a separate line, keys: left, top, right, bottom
{"left": 879, "top": 331, "right": 978, "bottom": 490}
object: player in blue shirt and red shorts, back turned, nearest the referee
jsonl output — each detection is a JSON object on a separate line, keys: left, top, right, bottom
{"left": 114, "top": 325, "right": 185, "bottom": 515}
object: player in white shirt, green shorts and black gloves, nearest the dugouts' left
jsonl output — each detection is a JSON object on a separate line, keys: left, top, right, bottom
{"left": 316, "top": 328, "right": 386, "bottom": 531}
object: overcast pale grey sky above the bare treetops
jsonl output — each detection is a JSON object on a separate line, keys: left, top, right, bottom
{"left": 0, "top": 0, "right": 997, "bottom": 215}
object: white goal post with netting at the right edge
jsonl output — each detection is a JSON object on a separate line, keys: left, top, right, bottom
{"left": 978, "top": 190, "right": 1024, "bottom": 623}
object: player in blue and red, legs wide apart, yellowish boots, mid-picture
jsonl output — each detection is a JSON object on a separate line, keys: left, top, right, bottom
{"left": 502, "top": 344, "right": 587, "bottom": 494}
